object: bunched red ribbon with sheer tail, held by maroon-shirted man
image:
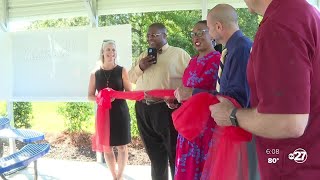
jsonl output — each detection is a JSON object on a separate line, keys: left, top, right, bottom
{"left": 172, "top": 93, "right": 252, "bottom": 180}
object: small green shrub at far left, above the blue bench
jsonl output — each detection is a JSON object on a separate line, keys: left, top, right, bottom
{"left": 13, "top": 102, "right": 33, "bottom": 128}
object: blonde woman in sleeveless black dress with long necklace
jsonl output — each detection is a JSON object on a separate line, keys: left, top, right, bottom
{"left": 88, "top": 40, "right": 131, "bottom": 180}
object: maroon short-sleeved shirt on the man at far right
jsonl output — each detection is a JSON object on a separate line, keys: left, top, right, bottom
{"left": 247, "top": 0, "right": 320, "bottom": 180}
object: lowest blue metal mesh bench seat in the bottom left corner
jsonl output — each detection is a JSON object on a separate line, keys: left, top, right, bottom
{"left": 0, "top": 144, "right": 50, "bottom": 180}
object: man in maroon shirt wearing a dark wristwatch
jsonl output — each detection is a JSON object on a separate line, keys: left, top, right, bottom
{"left": 210, "top": 0, "right": 320, "bottom": 180}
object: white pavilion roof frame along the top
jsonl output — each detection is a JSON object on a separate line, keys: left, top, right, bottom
{"left": 0, "top": 0, "right": 320, "bottom": 157}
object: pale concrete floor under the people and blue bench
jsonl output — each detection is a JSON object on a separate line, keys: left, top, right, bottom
{"left": 7, "top": 158, "right": 169, "bottom": 180}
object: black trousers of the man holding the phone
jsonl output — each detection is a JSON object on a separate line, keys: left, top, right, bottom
{"left": 135, "top": 102, "right": 178, "bottom": 180}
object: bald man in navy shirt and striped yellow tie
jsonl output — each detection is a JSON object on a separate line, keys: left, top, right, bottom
{"left": 207, "top": 4, "right": 259, "bottom": 180}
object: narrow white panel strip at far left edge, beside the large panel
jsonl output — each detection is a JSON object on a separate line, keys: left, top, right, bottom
{"left": 0, "top": 31, "right": 12, "bottom": 101}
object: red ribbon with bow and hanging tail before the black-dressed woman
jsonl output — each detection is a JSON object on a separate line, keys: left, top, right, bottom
{"left": 92, "top": 88, "right": 175, "bottom": 152}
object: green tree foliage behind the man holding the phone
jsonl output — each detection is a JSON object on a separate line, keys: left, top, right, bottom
{"left": 99, "top": 10, "right": 201, "bottom": 60}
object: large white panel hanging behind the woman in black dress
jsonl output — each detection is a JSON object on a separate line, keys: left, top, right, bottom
{"left": 11, "top": 25, "right": 132, "bottom": 101}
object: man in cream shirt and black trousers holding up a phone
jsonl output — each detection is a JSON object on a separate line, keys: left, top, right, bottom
{"left": 129, "top": 23, "right": 191, "bottom": 180}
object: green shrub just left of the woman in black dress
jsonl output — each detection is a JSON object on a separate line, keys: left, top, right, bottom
{"left": 58, "top": 102, "right": 94, "bottom": 132}
